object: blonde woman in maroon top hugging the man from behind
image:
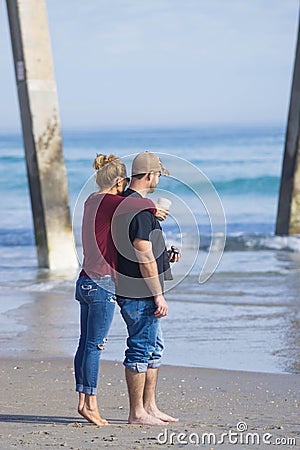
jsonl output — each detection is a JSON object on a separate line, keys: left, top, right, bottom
{"left": 74, "top": 155, "right": 166, "bottom": 425}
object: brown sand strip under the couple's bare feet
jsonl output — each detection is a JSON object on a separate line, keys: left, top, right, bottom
{"left": 0, "top": 358, "right": 300, "bottom": 450}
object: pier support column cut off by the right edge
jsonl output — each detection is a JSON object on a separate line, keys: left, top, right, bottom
{"left": 275, "top": 14, "right": 300, "bottom": 235}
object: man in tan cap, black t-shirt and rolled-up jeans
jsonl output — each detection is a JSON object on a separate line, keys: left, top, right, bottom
{"left": 116, "top": 152, "right": 180, "bottom": 425}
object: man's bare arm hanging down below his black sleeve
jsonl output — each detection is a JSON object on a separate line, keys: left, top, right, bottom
{"left": 133, "top": 238, "right": 168, "bottom": 318}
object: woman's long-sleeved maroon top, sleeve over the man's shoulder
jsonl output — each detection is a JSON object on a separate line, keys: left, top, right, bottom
{"left": 79, "top": 194, "right": 156, "bottom": 279}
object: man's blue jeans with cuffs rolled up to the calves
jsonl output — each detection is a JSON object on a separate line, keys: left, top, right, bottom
{"left": 117, "top": 297, "right": 164, "bottom": 372}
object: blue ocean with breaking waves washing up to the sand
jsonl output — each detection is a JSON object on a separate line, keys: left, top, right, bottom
{"left": 0, "top": 125, "right": 300, "bottom": 373}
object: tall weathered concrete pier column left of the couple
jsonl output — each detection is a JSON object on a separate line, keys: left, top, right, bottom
{"left": 6, "top": 0, "right": 78, "bottom": 269}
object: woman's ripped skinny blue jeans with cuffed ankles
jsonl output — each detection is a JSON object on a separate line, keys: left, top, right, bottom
{"left": 74, "top": 275, "right": 116, "bottom": 395}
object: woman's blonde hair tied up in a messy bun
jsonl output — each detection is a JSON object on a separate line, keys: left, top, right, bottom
{"left": 93, "top": 154, "right": 127, "bottom": 189}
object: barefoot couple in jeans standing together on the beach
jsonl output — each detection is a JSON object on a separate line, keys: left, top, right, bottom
{"left": 74, "top": 152, "right": 180, "bottom": 425}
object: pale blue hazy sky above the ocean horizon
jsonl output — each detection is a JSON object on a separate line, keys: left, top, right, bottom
{"left": 0, "top": 0, "right": 299, "bottom": 130}
